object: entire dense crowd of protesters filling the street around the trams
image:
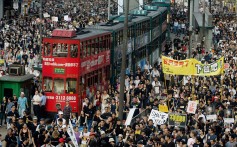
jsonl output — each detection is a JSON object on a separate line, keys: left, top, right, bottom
{"left": 0, "top": 1, "right": 237, "bottom": 147}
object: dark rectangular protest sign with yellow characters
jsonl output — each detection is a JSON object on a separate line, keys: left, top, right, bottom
{"left": 168, "top": 113, "right": 187, "bottom": 127}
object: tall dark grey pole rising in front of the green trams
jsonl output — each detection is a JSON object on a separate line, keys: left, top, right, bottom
{"left": 119, "top": 0, "right": 129, "bottom": 120}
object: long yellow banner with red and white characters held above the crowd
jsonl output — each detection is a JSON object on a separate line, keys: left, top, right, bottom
{"left": 162, "top": 56, "right": 224, "bottom": 76}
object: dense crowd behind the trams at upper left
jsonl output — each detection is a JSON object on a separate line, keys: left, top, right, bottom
{"left": 0, "top": 0, "right": 120, "bottom": 74}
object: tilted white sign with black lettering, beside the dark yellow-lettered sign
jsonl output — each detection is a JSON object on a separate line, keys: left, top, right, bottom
{"left": 149, "top": 109, "right": 168, "bottom": 126}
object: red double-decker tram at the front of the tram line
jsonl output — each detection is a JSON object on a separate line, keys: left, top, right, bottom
{"left": 42, "top": 29, "right": 111, "bottom": 113}
